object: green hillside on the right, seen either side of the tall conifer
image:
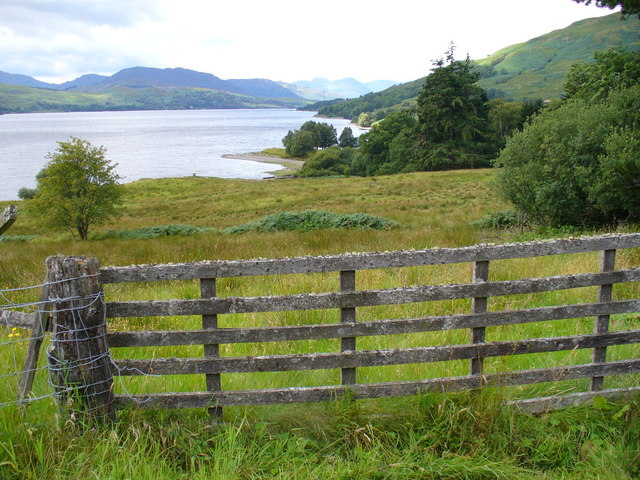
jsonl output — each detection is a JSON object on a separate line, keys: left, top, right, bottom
{"left": 305, "top": 13, "right": 640, "bottom": 120}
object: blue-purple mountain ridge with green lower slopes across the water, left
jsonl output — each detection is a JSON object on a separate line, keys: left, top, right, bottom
{"left": 0, "top": 67, "right": 308, "bottom": 113}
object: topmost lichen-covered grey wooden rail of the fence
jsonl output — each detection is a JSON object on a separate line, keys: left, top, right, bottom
{"left": 101, "top": 233, "right": 640, "bottom": 283}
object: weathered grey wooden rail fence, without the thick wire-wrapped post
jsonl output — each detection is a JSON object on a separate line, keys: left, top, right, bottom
{"left": 12, "top": 234, "right": 640, "bottom": 415}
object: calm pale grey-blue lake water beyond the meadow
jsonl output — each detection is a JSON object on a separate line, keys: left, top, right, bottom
{"left": 0, "top": 109, "right": 359, "bottom": 200}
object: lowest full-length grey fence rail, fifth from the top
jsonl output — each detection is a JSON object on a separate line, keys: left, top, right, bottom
{"left": 116, "top": 359, "right": 640, "bottom": 409}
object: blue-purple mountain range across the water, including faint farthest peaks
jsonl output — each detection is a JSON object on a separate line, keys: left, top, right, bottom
{"left": 0, "top": 67, "right": 394, "bottom": 113}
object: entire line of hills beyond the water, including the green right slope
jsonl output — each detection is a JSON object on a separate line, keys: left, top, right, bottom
{"left": 0, "top": 13, "right": 640, "bottom": 116}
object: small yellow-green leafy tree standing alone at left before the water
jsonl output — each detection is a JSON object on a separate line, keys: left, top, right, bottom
{"left": 28, "top": 137, "right": 124, "bottom": 240}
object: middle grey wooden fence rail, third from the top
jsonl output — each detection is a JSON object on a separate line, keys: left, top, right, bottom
{"left": 107, "top": 300, "right": 640, "bottom": 348}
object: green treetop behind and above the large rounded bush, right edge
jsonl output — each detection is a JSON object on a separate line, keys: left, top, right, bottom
{"left": 564, "top": 47, "right": 640, "bottom": 101}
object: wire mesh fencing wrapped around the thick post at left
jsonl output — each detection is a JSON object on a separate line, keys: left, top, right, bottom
{"left": 0, "top": 276, "right": 147, "bottom": 418}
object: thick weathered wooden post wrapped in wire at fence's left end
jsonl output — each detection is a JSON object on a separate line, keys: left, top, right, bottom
{"left": 46, "top": 256, "right": 115, "bottom": 422}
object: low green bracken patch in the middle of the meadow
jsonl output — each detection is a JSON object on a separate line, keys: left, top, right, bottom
{"left": 223, "top": 210, "right": 398, "bottom": 234}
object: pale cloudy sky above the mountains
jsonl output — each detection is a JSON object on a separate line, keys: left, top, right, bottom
{"left": 0, "top": 0, "right": 611, "bottom": 83}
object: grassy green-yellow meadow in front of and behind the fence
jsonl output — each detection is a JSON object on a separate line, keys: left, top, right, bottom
{"left": 0, "top": 170, "right": 640, "bottom": 479}
